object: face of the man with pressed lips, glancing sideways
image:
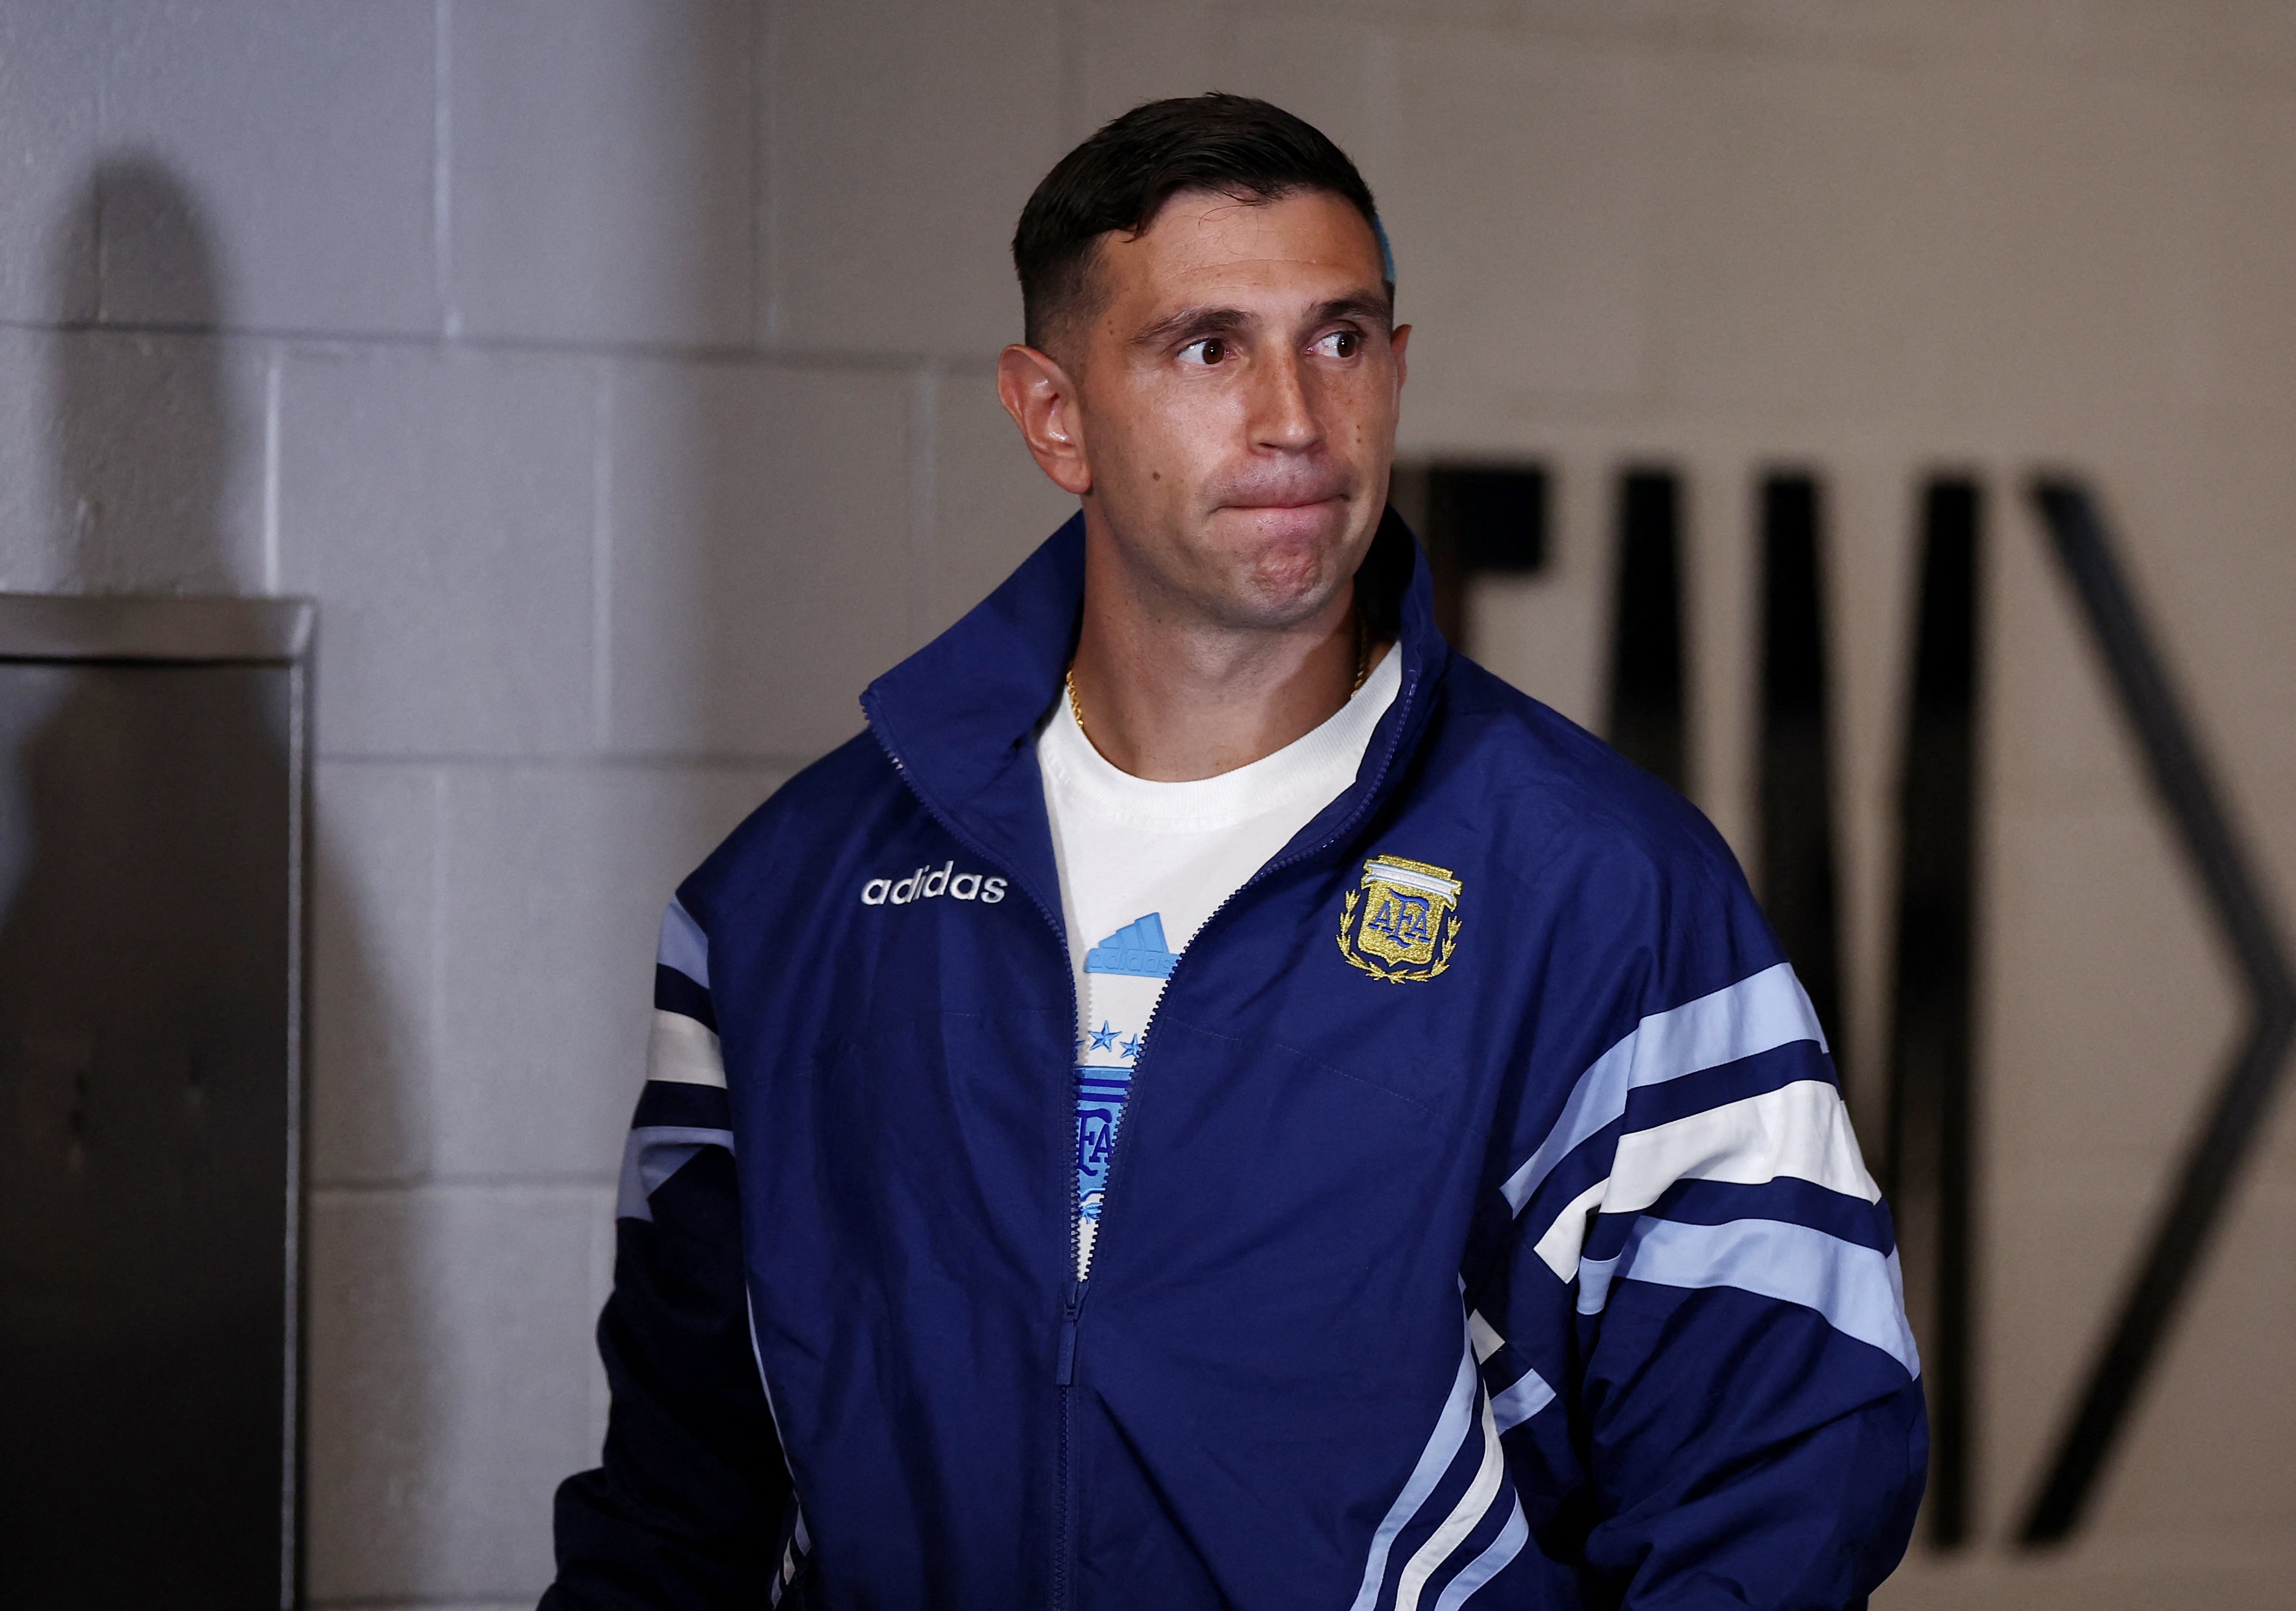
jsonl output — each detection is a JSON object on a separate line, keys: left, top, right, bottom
{"left": 1063, "top": 190, "right": 1410, "bottom": 627}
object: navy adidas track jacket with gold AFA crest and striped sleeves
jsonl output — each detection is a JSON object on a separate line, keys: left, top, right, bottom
{"left": 544, "top": 514, "right": 1926, "bottom": 1611}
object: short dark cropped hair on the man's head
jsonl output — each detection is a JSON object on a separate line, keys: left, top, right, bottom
{"left": 1013, "top": 92, "right": 1394, "bottom": 346}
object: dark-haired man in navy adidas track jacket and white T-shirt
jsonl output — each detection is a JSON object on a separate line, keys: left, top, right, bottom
{"left": 546, "top": 96, "right": 1926, "bottom": 1611}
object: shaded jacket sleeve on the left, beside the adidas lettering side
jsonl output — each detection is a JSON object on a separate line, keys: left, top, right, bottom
{"left": 542, "top": 902, "right": 801, "bottom": 1611}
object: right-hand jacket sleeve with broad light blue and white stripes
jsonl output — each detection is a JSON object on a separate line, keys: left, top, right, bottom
{"left": 1478, "top": 867, "right": 1929, "bottom": 1611}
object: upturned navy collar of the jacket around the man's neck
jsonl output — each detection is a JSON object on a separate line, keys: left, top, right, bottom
{"left": 861, "top": 507, "right": 1451, "bottom": 927}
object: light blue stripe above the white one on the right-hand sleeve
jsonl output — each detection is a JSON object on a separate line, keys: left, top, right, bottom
{"left": 1499, "top": 962, "right": 1825, "bottom": 1214}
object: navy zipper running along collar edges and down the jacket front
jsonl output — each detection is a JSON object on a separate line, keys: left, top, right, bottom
{"left": 870, "top": 661, "right": 1419, "bottom": 1611}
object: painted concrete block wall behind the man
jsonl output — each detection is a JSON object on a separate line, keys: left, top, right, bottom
{"left": 0, "top": 0, "right": 2296, "bottom": 1606}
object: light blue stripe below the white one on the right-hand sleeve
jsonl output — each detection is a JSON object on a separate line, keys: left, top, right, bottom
{"left": 1580, "top": 1218, "right": 1922, "bottom": 1377}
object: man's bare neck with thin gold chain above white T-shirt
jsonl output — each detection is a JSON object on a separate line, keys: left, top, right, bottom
{"left": 1070, "top": 548, "right": 1380, "bottom": 783}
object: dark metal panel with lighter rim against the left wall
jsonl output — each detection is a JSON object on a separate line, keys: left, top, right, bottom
{"left": 0, "top": 594, "right": 312, "bottom": 1611}
